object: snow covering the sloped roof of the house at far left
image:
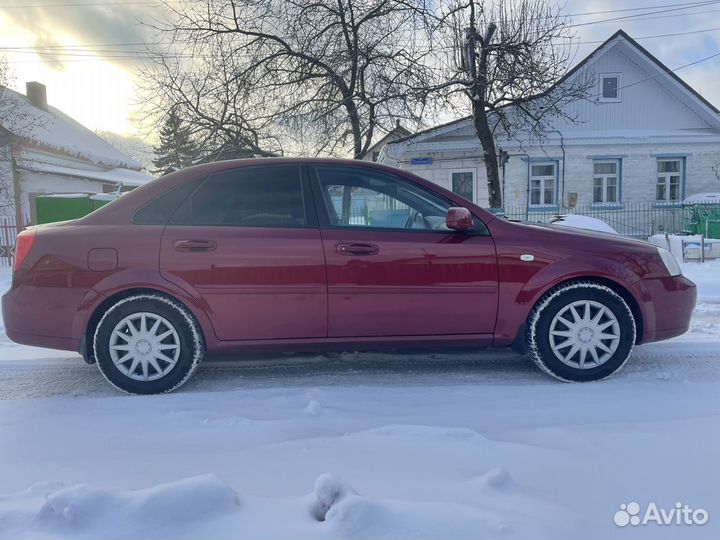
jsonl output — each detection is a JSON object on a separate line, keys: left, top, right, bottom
{"left": 0, "top": 87, "right": 143, "bottom": 170}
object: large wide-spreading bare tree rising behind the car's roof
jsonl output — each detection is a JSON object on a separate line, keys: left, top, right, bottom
{"left": 142, "top": 0, "right": 435, "bottom": 158}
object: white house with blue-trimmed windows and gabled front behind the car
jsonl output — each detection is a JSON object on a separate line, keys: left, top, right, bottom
{"left": 380, "top": 30, "right": 720, "bottom": 218}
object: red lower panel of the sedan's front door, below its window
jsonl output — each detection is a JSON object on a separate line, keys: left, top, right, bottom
{"left": 322, "top": 229, "right": 498, "bottom": 337}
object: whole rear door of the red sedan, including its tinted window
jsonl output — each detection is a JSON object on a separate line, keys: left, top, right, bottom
{"left": 160, "top": 164, "right": 327, "bottom": 340}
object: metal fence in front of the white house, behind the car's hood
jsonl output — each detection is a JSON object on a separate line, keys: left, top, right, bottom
{"left": 502, "top": 203, "right": 720, "bottom": 239}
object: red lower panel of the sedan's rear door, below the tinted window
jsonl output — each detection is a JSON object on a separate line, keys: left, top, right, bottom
{"left": 160, "top": 227, "right": 328, "bottom": 341}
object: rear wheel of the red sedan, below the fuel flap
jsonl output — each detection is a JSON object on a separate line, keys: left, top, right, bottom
{"left": 93, "top": 294, "right": 205, "bottom": 394}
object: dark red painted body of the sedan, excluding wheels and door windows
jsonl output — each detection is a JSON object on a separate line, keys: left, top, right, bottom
{"left": 3, "top": 159, "right": 696, "bottom": 351}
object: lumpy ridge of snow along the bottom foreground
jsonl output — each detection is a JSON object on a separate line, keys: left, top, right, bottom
{"left": 0, "top": 471, "right": 574, "bottom": 540}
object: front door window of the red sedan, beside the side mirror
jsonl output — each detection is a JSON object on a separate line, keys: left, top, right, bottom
{"left": 315, "top": 166, "right": 476, "bottom": 232}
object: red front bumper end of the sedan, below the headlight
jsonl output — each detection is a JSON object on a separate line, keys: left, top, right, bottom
{"left": 641, "top": 276, "right": 697, "bottom": 343}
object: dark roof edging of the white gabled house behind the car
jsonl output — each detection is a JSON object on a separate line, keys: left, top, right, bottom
{"left": 390, "top": 29, "right": 720, "bottom": 144}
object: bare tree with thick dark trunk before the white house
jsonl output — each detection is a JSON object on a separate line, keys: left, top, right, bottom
{"left": 441, "top": 0, "right": 594, "bottom": 208}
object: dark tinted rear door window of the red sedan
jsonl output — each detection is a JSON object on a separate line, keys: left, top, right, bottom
{"left": 171, "top": 165, "right": 307, "bottom": 227}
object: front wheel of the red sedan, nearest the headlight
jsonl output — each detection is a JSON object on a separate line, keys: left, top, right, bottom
{"left": 527, "top": 282, "right": 636, "bottom": 382}
